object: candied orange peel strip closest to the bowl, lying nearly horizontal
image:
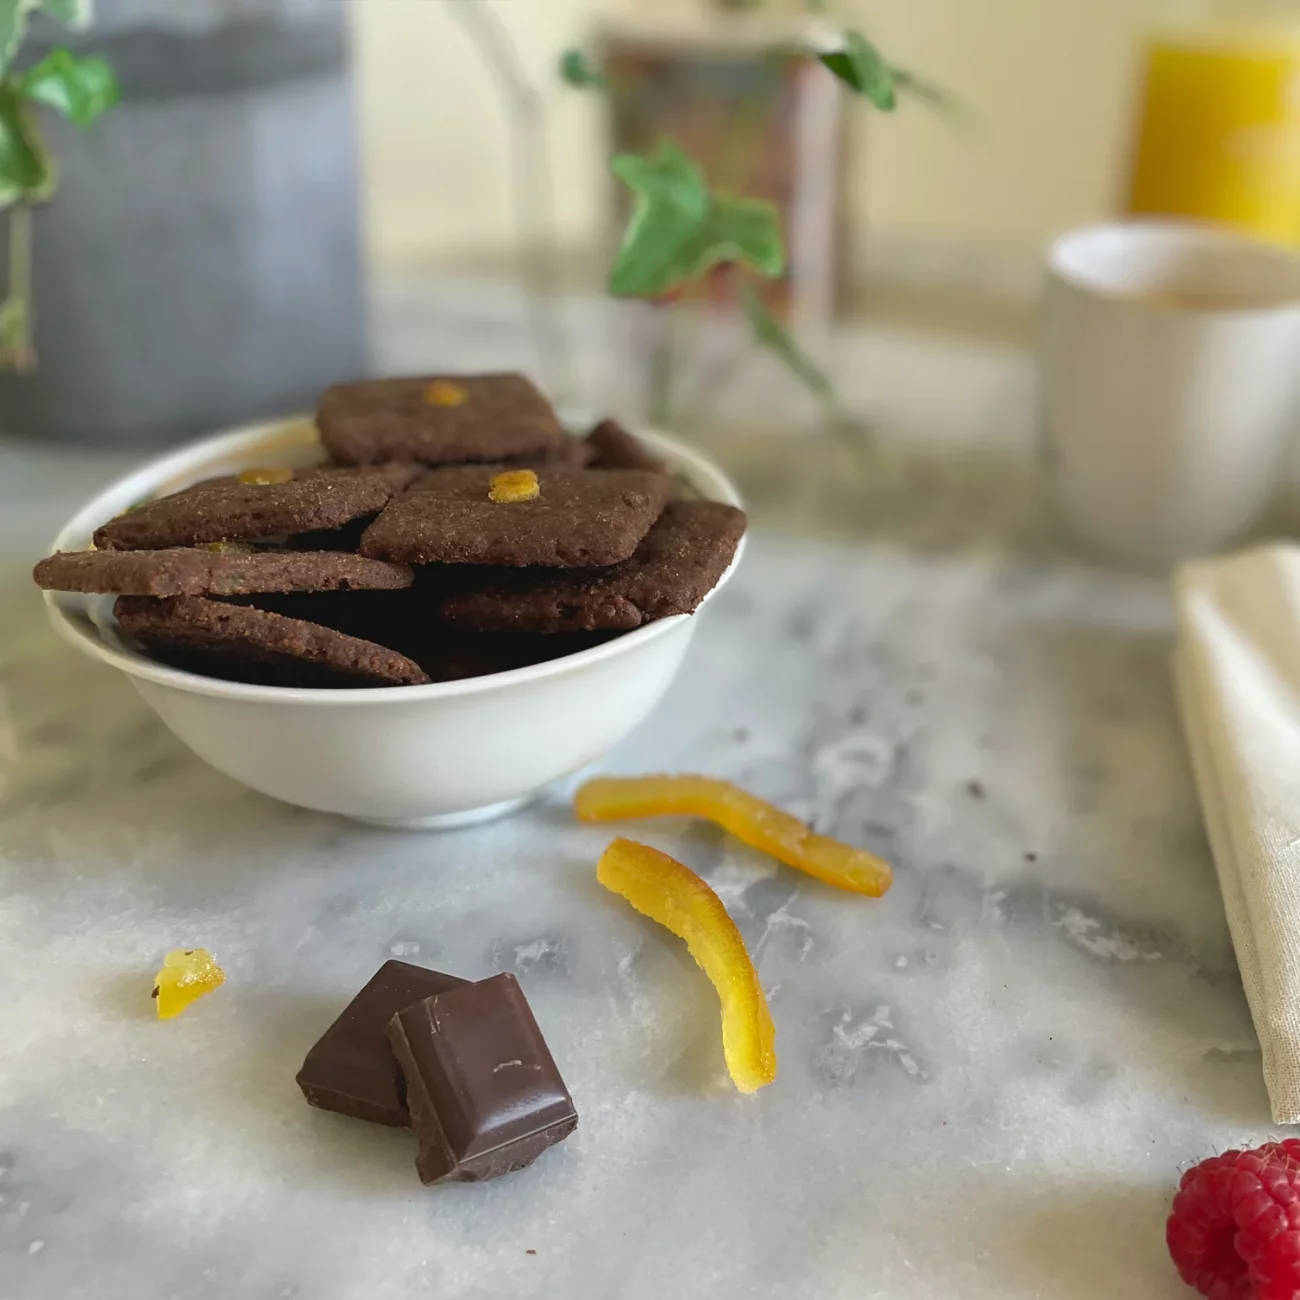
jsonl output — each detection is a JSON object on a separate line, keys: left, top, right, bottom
{"left": 573, "top": 776, "right": 893, "bottom": 898}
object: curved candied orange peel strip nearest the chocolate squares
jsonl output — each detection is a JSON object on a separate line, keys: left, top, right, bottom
{"left": 595, "top": 840, "right": 776, "bottom": 1092}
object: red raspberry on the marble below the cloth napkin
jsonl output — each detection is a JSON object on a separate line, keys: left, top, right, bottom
{"left": 1165, "top": 1138, "right": 1300, "bottom": 1300}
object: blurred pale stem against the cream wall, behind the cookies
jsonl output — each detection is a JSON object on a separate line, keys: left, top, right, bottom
{"left": 447, "top": 0, "right": 573, "bottom": 400}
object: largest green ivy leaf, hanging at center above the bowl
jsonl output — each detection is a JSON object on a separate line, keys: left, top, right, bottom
{"left": 610, "top": 140, "right": 785, "bottom": 298}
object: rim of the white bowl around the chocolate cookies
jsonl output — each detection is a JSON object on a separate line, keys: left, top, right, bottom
{"left": 42, "top": 415, "right": 748, "bottom": 707}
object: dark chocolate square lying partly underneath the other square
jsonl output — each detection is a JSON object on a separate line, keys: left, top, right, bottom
{"left": 298, "top": 962, "right": 465, "bottom": 1128}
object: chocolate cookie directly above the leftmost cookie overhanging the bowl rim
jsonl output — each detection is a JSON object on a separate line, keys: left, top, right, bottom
{"left": 95, "top": 465, "right": 421, "bottom": 551}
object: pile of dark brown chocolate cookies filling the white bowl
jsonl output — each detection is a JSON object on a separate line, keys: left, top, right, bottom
{"left": 35, "top": 374, "right": 745, "bottom": 686}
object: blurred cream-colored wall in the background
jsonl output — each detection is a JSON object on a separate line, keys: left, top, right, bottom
{"left": 354, "top": 0, "right": 1145, "bottom": 265}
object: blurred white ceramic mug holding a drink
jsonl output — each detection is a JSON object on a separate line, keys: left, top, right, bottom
{"left": 1041, "top": 221, "right": 1300, "bottom": 560}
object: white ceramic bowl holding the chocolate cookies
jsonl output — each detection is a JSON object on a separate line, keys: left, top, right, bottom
{"left": 46, "top": 420, "right": 740, "bottom": 828}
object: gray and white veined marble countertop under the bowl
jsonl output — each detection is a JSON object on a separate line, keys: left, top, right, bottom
{"left": 0, "top": 299, "right": 1270, "bottom": 1300}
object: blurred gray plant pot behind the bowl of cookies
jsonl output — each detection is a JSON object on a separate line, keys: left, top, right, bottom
{"left": 0, "top": 0, "right": 367, "bottom": 443}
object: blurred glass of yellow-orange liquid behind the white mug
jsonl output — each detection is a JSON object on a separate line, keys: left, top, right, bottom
{"left": 1127, "top": 0, "right": 1300, "bottom": 244}
